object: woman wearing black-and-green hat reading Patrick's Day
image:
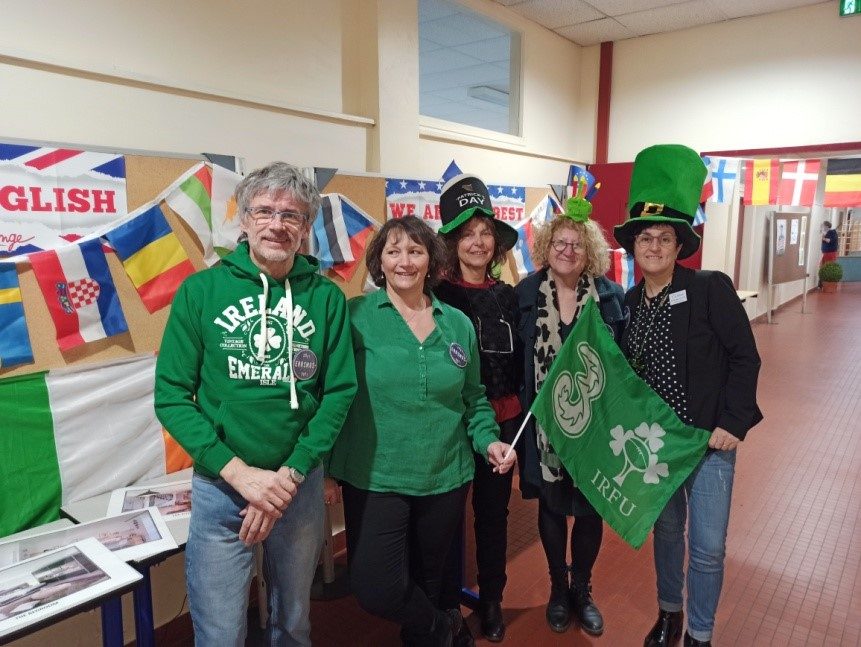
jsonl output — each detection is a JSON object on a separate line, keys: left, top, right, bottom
{"left": 434, "top": 174, "right": 523, "bottom": 645}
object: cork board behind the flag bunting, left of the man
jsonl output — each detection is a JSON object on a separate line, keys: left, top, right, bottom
{"left": 0, "top": 155, "right": 204, "bottom": 379}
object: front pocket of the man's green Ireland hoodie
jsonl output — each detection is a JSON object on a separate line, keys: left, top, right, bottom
{"left": 216, "top": 397, "right": 308, "bottom": 469}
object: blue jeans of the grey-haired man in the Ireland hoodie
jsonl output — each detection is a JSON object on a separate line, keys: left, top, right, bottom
{"left": 185, "top": 467, "right": 325, "bottom": 647}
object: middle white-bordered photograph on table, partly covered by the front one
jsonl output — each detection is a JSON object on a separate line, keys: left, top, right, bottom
{"left": 0, "top": 508, "right": 177, "bottom": 567}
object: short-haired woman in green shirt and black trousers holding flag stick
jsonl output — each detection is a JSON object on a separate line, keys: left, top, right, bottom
{"left": 329, "top": 216, "right": 514, "bottom": 645}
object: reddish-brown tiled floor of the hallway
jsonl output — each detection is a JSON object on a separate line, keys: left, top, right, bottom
{"left": 312, "top": 283, "right": 861, "bottom": 647}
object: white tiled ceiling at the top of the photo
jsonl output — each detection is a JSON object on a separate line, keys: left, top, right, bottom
{"left": 494, "top": 0, "right": 827, "bottom": 45}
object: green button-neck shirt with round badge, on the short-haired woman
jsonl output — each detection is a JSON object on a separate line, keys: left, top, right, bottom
{"left": 328, "top": 290, "right": 499, "bottom": 496}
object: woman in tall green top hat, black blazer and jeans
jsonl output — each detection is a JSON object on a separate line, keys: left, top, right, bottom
{"left": 615, "top": 145, "right": 762, "bottom": 647}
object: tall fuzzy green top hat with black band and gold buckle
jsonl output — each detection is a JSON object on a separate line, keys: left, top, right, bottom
{"left": 613, "top": 144, "right": 706, "bottom": 259}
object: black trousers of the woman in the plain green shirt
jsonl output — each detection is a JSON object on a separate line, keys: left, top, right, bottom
{"left": 343, "top": 483, "right": 469, "bottom": 634}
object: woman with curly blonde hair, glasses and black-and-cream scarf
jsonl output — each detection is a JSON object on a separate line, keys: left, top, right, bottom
{"left": 515, "top": 187, "right": 625, "bottom": 635}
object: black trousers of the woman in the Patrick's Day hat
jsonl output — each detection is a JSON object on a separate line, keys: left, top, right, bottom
{"left": 440, "top": 416, "right": 522, "bottom": 609}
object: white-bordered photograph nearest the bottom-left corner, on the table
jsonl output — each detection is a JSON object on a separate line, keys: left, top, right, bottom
{"left": 0, "top": 538, "right": 141, "bottom": 638}
